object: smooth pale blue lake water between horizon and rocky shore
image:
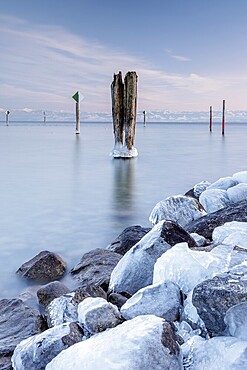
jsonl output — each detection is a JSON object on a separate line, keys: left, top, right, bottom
{"left": 0, "top": 123, "right": 247, "bottom": 298}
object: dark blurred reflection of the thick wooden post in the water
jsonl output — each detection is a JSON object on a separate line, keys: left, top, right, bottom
{"left": 112, "top": 158, "right": 135, "bottom": 226}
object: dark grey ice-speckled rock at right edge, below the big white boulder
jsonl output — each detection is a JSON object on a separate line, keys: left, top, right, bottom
{"left": 192, "top": 265, "right": 247, "bottom": 336}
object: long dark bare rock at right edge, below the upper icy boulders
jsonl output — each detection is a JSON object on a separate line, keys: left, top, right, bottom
{"left": 185, "top": 199, "right": 247, "bottom": 240}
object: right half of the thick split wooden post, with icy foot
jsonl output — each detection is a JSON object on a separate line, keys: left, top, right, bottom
{"left": 124, "top": 72, "right": 138, "bottom": 157}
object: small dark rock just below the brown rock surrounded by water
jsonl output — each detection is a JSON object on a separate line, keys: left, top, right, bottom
{"left": 37, "top": 281, "right": 70, "bottom": 306}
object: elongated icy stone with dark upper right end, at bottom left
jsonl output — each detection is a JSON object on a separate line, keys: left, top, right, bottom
{"left": 12, "top": 323, "right": 83, "bottom": 370}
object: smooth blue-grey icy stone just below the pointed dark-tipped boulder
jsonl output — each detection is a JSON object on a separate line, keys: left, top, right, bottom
{"left": 120, "top": 281, "right": 182, "bottom": 321}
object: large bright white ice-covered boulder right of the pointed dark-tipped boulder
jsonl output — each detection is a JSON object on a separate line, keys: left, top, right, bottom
{"left": 153, "top": 243, "right": 233, "bottom": 294}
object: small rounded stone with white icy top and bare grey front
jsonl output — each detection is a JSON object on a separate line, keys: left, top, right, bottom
{"left": 78, "top": 297, "right": 122, "bottom": 335}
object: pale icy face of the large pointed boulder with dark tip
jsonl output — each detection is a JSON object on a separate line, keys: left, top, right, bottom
{"left": 109, "top": 221, "right": 171, "bottom": 294}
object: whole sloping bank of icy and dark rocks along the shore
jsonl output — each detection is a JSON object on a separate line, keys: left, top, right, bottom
{"left": 0, "top": 171, "right": 247, "bottom": 370}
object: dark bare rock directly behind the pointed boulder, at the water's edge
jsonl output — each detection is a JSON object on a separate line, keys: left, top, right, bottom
{"left": 107, "top": 225, "right": 151, "bottom": 255}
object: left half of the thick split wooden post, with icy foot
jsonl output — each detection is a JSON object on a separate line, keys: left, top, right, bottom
{"left": 111, "top": 72, "right": 124, "bottom": 157}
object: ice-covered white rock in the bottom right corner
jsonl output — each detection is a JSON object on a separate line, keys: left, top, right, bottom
{"left": 182, "top": 336, "right": 247, "bottom": 370}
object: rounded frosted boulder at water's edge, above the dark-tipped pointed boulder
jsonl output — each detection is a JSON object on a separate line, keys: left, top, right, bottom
{"left": 149, "top": 195, "right": 205, "bottom": 227}
